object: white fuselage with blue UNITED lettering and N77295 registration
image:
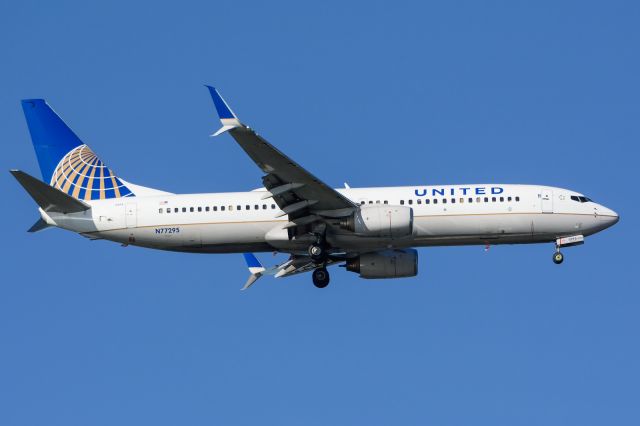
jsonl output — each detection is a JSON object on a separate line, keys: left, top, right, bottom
{"left": 41, "top": 184, "right": 618, "bottom": 253}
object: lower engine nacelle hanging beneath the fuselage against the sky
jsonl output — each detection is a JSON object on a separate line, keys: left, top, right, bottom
{"left": 347, "top": 249, "right": 418, "bottom": 279}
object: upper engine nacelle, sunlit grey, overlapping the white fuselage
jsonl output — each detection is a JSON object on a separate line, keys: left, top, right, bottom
{"left": 340, "top": 204, "right": 413, "bottom": 238}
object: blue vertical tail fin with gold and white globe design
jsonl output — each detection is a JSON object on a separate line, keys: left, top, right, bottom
{"left": 22, "top": 99, "right": 134, "bottom": 200}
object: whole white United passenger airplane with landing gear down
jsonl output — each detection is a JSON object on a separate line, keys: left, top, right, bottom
{"left": 11, "top": 86, "right": 619, "bottom": 289}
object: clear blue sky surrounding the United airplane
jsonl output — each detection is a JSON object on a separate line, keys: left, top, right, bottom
{"left": 0, "top": 1, "right": 640, "bottom": 426}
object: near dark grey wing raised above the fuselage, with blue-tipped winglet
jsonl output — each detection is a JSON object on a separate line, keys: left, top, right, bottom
{"left": 207, "top": 86, "right": 357, "bottom": 228}
